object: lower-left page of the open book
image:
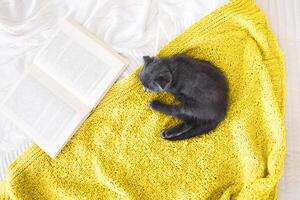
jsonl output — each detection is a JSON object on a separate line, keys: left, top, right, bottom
{"left": 1, "top": 73, "right": 89, "bottom": 157}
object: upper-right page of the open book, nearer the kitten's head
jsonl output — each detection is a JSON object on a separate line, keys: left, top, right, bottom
{"left": 35, "top": 19, "right": 126, "bottom": 108}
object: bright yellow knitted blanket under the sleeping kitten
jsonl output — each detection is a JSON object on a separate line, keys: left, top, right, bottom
{"left": 0, "top": 0, "right": 286, "bottom": 200}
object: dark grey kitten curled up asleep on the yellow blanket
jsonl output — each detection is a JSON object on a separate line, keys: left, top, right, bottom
{"left": 139, "top": 55, "right": 228, "bottom": 140}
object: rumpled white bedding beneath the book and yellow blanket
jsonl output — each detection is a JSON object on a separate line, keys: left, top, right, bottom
{"left": 0, "top": 0, "right": 300, "bottom": 199}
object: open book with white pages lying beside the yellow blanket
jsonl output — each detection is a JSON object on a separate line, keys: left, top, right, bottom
{"left": 0, "top": 20, "right": 127, "bottom": 158}
